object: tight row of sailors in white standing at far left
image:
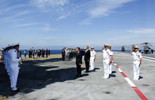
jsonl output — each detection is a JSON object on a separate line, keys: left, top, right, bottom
{"left": 3, "top": 44, "right": 22, "bottom": 92}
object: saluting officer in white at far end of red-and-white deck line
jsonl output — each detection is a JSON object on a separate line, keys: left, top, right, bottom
{"left": 102, "top": 44, "right": 112, "bottom": 79}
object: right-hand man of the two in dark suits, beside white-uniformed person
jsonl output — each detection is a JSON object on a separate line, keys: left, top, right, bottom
{"left": 84, "top": 46, "right": 90, "bottom": 72}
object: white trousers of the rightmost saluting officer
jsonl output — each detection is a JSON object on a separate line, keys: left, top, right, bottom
{"left": 133, "top": 61, "right": 140, "bottom": 80}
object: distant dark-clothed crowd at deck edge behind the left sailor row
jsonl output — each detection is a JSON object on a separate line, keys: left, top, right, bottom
{"left": 24, "top": 49, "right": 51, "bottom": 59}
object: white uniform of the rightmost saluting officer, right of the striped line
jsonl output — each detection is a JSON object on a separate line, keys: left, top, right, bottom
{"left": 131, "top": 52, "right": 142, "bottom": 80}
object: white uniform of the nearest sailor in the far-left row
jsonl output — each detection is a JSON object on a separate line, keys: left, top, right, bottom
{"left": 10, "top": 49, "right": 21, "bottom": 90}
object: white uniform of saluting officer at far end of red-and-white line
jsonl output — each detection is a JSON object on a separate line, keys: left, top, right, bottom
{"left": 102, "top": 49, "right": 111, "bottom": 79}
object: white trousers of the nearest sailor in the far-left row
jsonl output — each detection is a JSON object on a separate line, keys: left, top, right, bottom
{"left": 10, "top": 66, "right": 19, "bottom": 90}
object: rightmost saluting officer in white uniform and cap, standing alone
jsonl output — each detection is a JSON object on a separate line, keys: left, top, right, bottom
{"left": 131, "top": 46, "right": 142, "bottom": 80}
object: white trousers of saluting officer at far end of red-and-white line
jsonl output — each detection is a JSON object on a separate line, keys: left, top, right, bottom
{"left": 103, "top": 59, "right": 110, "bottom": 78}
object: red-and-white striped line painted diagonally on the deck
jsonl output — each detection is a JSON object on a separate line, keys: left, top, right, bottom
{"left": 113, "top": 62, "right": 148, "bottom": 100}
